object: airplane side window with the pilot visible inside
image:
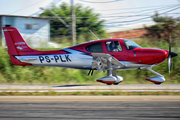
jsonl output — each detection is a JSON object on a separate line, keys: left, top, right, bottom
{"left": 106, "top": 41, "right": 122, "bottom": 52}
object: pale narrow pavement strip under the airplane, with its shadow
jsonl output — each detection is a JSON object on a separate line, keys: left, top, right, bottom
{"left": 0, "top": 84, "right": 180, "bottom": 92}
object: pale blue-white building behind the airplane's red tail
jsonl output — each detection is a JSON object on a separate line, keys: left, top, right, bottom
{"left": 0, "top": 15, "right": 50, "bottom": 48}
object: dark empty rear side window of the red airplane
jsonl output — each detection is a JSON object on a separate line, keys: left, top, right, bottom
{"left": 86, "top": 43, "right": 103, "bottom": 52}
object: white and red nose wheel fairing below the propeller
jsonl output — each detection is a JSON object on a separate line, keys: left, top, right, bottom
{"left": 146, "top": 76, "right": 165, "bottom": 85}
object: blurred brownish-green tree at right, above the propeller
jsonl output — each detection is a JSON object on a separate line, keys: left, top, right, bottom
{"left": 145, "top": 13, "right": 180, "bottom": 44}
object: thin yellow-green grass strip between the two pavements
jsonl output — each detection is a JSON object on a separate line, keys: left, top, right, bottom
{"left": 0, "top": 91, "right": 180, "bottom": 96}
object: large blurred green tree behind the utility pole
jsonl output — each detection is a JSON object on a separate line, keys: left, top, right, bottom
{"left": 40, "top": 3, "right": 105, "bottom": 42}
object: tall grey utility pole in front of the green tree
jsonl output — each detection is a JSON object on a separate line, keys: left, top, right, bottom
{"left": 71, "top": 0, "right": 76, "bottom": 45}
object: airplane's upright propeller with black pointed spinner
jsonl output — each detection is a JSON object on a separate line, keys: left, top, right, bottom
{"left": 168, "top": 35, "right": 178, "bottom": 74}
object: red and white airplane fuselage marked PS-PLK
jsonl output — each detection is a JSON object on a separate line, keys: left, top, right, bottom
{"left": 14, "top": 39, "right": 168, "bottom": 69}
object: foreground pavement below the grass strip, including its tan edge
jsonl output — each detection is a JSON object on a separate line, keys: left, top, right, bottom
{"left": 0, "top": 96, "right": 180, "bottom": 120}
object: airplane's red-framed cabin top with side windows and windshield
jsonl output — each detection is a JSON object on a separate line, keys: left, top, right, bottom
{"left": 72, "top": 39, "right": 141, "bottom": 52}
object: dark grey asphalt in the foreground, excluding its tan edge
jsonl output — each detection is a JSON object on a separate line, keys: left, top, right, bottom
{"left": 0, "top": 102, "right": 180, "bottom": 120}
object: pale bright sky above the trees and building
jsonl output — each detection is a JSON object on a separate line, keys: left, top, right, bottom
{"left": 0, "top": 0, "right": 180, "bottom": 27}
